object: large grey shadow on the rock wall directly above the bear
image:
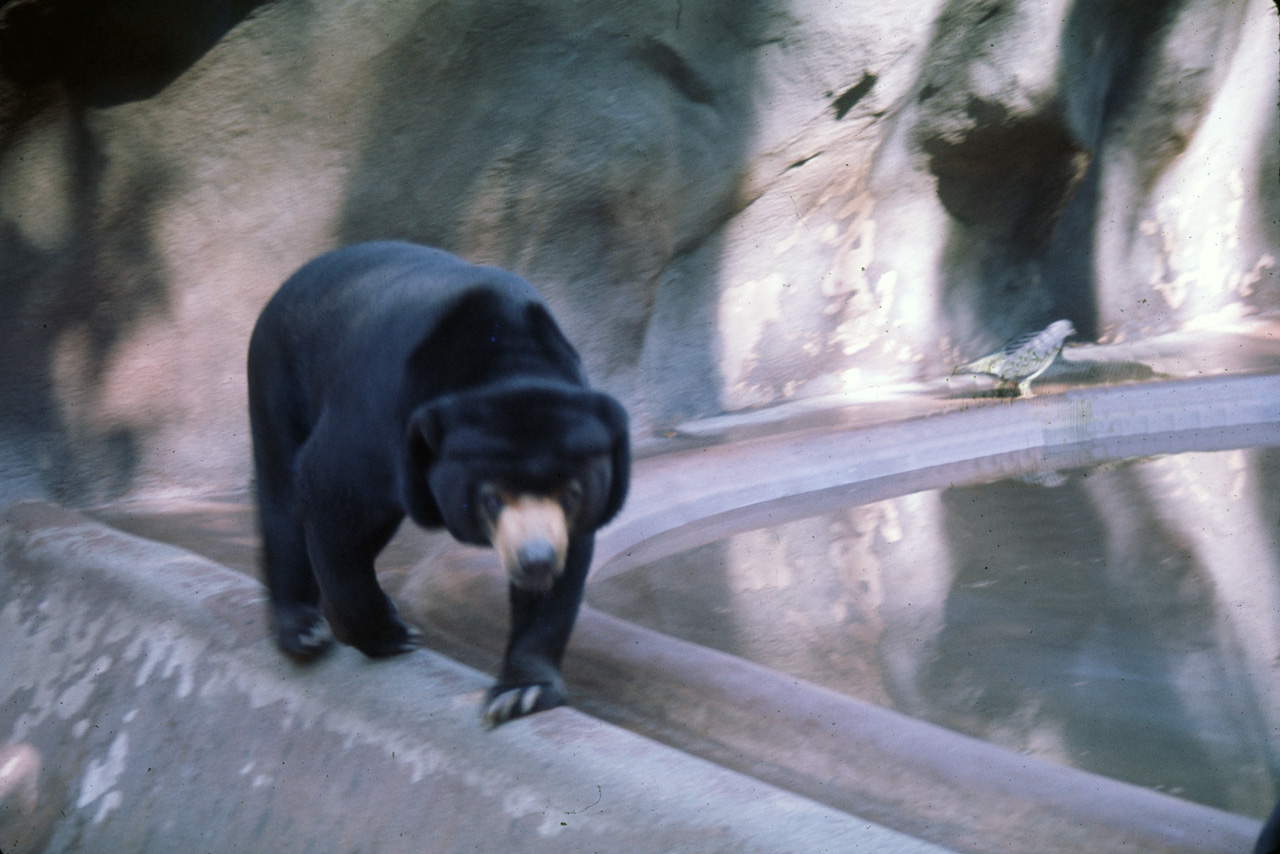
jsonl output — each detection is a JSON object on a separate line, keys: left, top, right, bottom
{"left": 338, "top": 0, "right": 768, "bottom": 424}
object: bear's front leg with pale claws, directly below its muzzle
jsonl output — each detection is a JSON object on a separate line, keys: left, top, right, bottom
{"left": 484, "top": 534, "right": 595, "bottom": 727}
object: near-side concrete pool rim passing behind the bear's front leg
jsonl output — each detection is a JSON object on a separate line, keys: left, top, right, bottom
{"left": 412, "top": 555, "right": 1261, "bottom": 854}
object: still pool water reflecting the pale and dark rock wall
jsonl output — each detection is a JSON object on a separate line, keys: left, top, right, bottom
{"left": 590, "top": 448, "right": 1280, "bottom": 817}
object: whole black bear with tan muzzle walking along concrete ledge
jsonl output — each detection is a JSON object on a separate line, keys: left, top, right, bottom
{"left": 248, "top": 242, "right": 631, "bottom": 726}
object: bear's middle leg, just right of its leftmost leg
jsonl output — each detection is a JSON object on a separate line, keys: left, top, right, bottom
{"left": 306, "top": 501, "right": 417, "bottom": 658}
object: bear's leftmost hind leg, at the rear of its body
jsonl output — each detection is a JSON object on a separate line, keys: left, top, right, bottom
{"left": 257, "top": 475, "right": 333, "bottom": 662}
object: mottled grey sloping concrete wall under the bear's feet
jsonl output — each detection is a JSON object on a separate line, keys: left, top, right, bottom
{"left": 0, "top": 502, "right": 941, "bottom": 854}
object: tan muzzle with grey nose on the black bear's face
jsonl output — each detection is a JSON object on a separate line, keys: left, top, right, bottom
{"left": 492, "top": 495, "right": 568, "bottom": 590}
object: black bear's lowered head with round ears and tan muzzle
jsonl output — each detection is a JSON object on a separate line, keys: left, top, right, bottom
{"left": 403, "top": 382, "right": 631, "bottom": 592}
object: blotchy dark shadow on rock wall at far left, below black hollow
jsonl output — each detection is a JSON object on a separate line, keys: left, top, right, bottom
{"left": 0, "top": 100, "right": 173, "bottom": 503}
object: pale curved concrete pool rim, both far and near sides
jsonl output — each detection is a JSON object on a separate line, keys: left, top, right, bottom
{"left": 568, "top": 375, "right": 1280, "bottom": 854}
